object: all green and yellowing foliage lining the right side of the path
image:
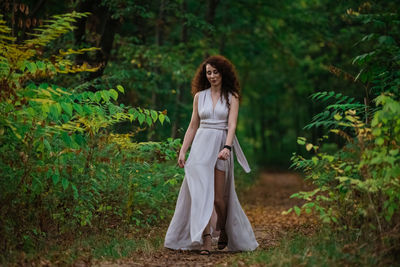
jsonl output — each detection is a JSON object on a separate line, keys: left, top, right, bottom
{"left": 287, "top": 4, "right": 400, "bottom": 262}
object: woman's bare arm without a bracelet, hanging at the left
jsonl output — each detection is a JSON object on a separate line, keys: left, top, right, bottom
{"left": 178, "top": 93, "right": 200, "bottom": 168}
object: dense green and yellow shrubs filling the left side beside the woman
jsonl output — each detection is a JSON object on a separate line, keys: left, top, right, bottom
{"left": 0, "top": 12, "right": 182, "bottom": 258}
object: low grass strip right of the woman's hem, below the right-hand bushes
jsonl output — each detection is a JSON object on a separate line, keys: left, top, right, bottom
{"left": 225, "top": 229, "right": 384, "bottom": 267}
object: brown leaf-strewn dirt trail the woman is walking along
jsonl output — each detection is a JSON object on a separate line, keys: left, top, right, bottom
{"left": 96, "top": 173, "right": 314, "bottom": 266}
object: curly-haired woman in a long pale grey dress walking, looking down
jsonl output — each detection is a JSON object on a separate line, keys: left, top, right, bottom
{"left": 164, "top": 55, "right": 258, "bottom": 255}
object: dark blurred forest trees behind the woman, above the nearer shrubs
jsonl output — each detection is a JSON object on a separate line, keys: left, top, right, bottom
{"left": 2, "top": 0, "right": 382, "bottom": 167}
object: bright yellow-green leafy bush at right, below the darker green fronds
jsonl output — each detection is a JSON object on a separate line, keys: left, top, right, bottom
{"left": 292, "top": 100, "right": 400, "bottom": 226}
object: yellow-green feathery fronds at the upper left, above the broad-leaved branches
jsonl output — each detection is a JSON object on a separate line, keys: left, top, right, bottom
{"left": 0, "top": 12, "right": 102, "bottom": 101}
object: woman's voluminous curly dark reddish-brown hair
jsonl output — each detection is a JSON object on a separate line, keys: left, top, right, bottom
{"left": 192, "top": 55, "right": 241, "bottom": 108}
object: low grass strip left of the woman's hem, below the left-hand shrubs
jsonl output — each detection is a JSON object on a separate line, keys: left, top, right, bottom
{"left": 1, "top": 225, "right": 165, "bottom": 266}
